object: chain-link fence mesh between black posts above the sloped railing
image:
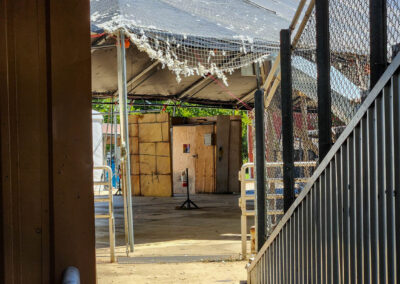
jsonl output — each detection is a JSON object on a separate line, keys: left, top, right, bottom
{"left": 258, "top": 0, "right": 400, "bottom": 235}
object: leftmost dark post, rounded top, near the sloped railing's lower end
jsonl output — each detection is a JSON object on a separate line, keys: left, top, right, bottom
{"left": 254, "top": 89, "right": 265, "bottom": 248}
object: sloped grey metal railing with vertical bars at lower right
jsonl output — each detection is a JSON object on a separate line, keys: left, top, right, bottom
{"left": 248, "top": 52, "right": 400, "bottom": 283}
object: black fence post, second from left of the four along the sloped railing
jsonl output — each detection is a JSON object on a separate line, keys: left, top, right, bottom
{"left": 280, "top": 30, "right": 295, "bottom": 212}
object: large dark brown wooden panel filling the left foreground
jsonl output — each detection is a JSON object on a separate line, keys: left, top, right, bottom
{"left": 0, "top": 0, "right": 96, "bottom": 283}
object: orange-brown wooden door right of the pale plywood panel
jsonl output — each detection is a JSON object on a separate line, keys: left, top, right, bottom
{"left": 192, "top": 124, "right": 215, "bottom": 193}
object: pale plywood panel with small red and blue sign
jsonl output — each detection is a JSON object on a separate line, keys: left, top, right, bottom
{"left": 172, "top": 126, "right": 196, "bottom": 194}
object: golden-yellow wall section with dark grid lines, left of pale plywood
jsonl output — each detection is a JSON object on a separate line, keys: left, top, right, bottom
{"left": 129, "top": 113, "right": 172, "bottom": 196}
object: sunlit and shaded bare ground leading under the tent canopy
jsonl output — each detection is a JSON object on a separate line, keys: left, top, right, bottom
{"left": 96, "top": 195, "right": 251, "bottom": 283}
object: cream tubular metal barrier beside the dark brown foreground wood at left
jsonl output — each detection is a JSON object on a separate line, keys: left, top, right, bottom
{"left": 93, "top": 166, "right": 115, "bottom": 262}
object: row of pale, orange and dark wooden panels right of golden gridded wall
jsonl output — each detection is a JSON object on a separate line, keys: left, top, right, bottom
{"left": 172, "top": 115, "right": 242, "bottom": 193}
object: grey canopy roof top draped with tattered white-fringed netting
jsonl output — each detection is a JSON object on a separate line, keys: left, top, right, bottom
{"left": 91, "top": 0, "right": 298, "bottom": 85}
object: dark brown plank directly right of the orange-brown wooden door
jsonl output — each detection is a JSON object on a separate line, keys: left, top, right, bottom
{"left": 215, "top": 115, "right": 231, "bottom": 193}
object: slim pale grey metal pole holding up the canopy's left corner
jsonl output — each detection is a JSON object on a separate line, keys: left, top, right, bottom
{"left": 117, "top": 30, "right": 134, "bottom": 252}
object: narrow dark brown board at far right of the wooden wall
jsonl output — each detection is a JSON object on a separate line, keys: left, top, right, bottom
{"left": 228, "top": 120, "right": 242, "bottom": 193}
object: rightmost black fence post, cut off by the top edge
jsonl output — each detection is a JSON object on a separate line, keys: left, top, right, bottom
{"left": 369, "top": 0, "right": 387, "bottom": 90}
